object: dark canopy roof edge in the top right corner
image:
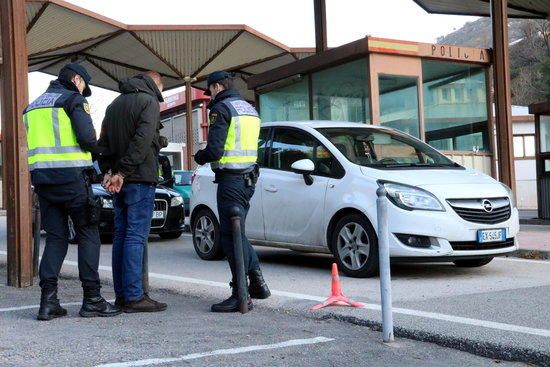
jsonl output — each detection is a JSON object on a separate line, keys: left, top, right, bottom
{"left": 414, "top": 0, "right": 550, "bottom": 19}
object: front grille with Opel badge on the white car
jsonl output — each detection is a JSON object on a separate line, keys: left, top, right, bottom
{"left": 447, "top": 198, "right": 512, "bottom": 224}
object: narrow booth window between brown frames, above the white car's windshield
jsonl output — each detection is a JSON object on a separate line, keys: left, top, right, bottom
{"left": 378, "top": 74, "right": 422, "bottom": 138}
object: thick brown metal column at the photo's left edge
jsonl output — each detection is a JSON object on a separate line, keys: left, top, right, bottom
{"left": 0, "top": 0, "right": 33, "bottom": 287}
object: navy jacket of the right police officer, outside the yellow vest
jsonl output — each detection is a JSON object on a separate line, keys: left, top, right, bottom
{"left": 195, "top": 89, "right": 253, "bottom": 173}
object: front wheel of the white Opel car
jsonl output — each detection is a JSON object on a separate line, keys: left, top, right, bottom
{"left": 331, "top": 214, "right": 378, "bottom": 278}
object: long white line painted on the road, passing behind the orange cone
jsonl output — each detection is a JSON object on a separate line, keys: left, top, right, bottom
{"left": 0, "top": 251, "right": 550, "bottom": 338}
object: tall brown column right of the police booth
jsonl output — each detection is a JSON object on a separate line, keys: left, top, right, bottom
{"left": 491, "top": 0, "right": 516, "bottom": 192}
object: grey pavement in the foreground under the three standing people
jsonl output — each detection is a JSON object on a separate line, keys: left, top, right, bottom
{"left": 0, "top": 265, "right": 522, "bottom": 367}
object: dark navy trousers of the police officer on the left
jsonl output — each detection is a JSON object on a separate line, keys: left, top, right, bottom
{"left": 35, "top": 178, "right": 101, "bottom": 297}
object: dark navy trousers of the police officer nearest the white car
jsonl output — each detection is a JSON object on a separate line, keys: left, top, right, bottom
{"left": 216, "top": 175, "right": 260, "bottom": 279}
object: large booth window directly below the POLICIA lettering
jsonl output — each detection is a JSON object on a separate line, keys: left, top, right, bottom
{"left": 422, "top": 60, "right": 489, "bottom": 152}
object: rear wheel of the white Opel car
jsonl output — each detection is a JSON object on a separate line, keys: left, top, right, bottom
{"left": 191, "top": 209, "right": 224, "bottom": 260}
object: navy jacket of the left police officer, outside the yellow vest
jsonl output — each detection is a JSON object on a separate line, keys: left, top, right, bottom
{"left": 23, "top": 80, "right": 108, "bottom": 185}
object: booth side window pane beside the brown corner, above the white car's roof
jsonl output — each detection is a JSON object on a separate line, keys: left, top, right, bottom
{"left": 311, "top": 59, "right": 370, "bottom": 123}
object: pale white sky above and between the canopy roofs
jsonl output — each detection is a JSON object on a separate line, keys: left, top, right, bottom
{"left": 29, "top": 0, "right": 477, "bottom": 128}
